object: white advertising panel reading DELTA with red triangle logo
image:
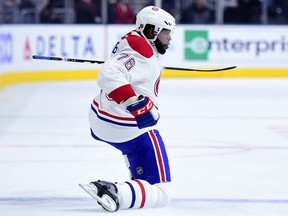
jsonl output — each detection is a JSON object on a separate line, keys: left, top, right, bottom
{"left": 0, "top": 25, "right": 105, "bottom": 73}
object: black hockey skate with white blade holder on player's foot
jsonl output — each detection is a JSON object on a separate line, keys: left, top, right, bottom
{"left": 79, "top": 180, "right": 119, "bottom": 212}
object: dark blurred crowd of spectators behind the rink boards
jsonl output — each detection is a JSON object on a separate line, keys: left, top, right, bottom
{"left": 0, "top": 0, "right": 288, "bottom": 24}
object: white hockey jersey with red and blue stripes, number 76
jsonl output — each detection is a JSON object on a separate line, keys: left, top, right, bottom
{"left": 89, "top": 30, "right": 162, "bottom": 143}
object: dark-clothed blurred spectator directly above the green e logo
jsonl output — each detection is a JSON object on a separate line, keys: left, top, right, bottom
{"left": 181, "top": 0, "right": 215, "bottom": 24}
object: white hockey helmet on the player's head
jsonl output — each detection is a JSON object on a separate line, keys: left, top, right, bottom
{"left": 136, "top": 6, "right": 176, "bottom": 42}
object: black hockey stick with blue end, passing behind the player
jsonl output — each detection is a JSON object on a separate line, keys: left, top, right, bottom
{"left": 32, "top": 55, "right": 237, "bottom": 72}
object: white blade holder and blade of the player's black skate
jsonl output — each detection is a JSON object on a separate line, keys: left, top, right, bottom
{"left": 79, "top": 184, "right": 117, "bottom": 212}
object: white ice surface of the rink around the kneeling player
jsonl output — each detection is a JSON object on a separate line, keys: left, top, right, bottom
{"left": 0, "top": 79, "right": 288, "bottom": 216}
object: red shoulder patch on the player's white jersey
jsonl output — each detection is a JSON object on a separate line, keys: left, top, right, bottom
{"left": 125, "top": 33, "right": 153, "bottom": 58}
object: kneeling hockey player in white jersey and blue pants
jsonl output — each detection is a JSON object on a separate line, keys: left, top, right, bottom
{"left": 80, "top": 6, "right": 175, "bottom": 212}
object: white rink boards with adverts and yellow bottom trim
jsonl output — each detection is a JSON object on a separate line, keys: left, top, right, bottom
{"left": 0, "top": 25, "right": 288, "bottom": 87}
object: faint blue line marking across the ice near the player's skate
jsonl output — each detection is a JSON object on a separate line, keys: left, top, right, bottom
{"left": 0, "top": 197, "right": 288, "bottom": 204}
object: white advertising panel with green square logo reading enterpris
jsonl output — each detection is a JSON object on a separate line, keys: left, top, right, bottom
{"left": 168, "top": 26, "right": 288, "bottom": 68}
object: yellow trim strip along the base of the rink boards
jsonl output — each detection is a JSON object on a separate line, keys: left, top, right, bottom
{"left": 0, "top": 68, "right": 288, "bottom": 88}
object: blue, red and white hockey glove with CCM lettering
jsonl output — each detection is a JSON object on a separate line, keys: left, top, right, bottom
{"left": 127, "top": 95, "right": 159, "bottom": 129}
